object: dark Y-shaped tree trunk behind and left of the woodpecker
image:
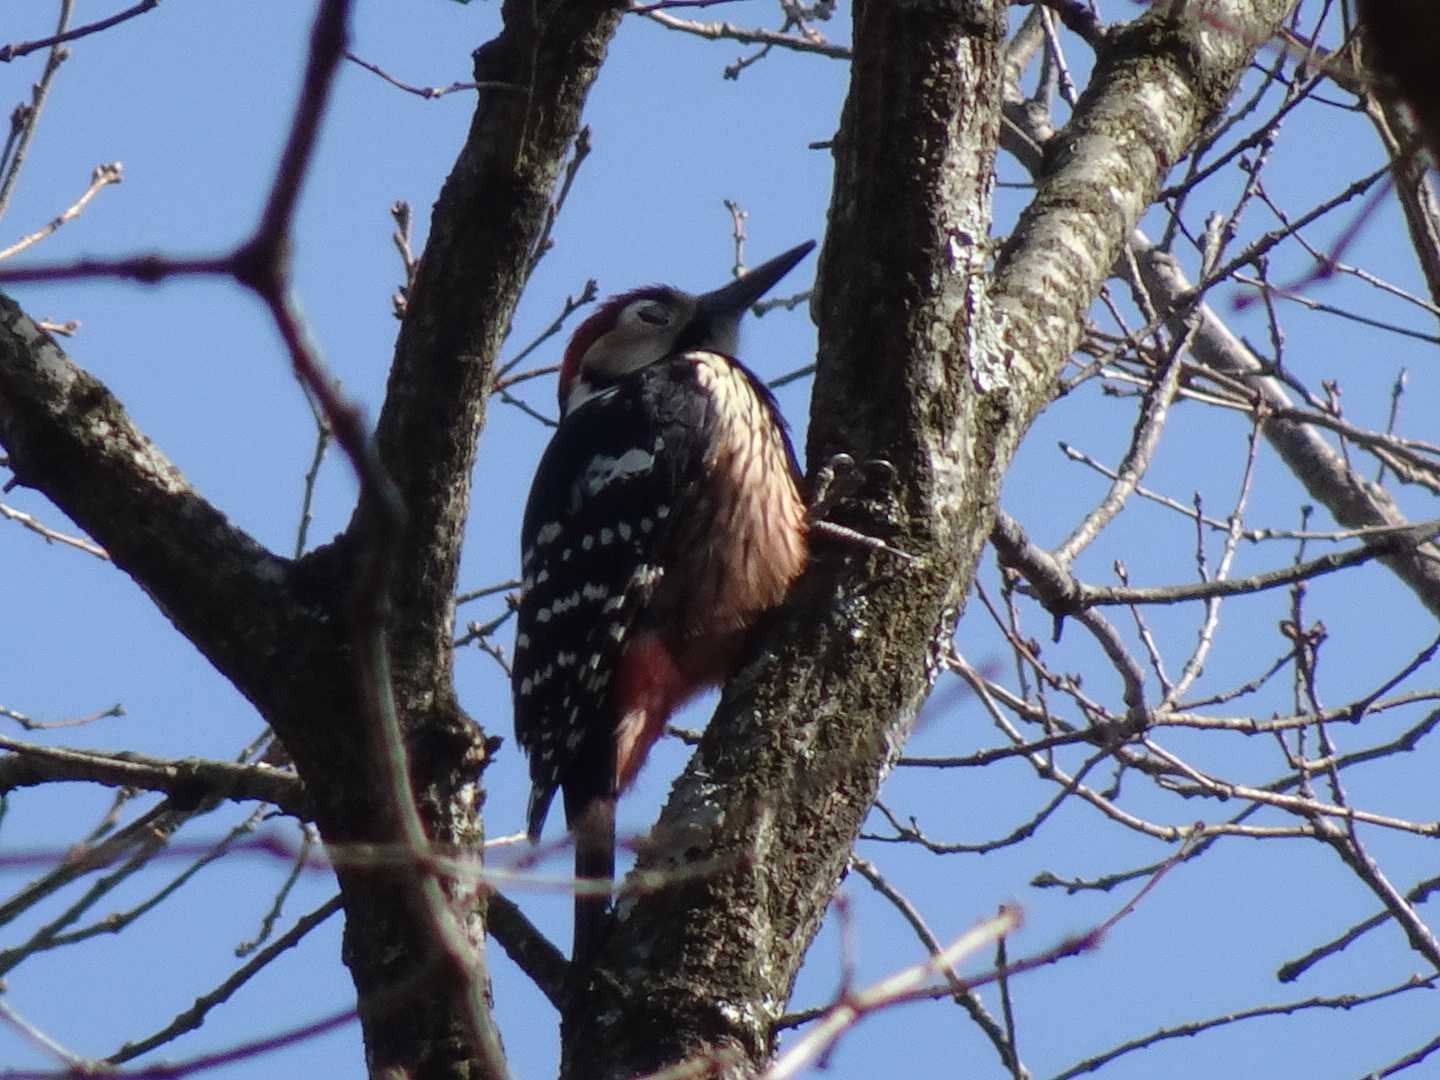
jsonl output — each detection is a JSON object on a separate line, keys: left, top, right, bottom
{"left": 0, "top": 0, "right": 622, "bottom": 1077}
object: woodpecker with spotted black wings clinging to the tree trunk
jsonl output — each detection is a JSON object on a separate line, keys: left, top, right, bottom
{"left": 513, "top": 242, "right": 815, "bottom": 968}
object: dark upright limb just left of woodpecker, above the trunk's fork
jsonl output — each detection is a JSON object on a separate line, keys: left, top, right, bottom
{"left": 360, "top": 0, "right": 625, "bottom": 687}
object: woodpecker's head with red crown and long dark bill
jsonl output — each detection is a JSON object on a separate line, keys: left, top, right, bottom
{"left": 559, "top": 240, "right": 815, "bottom": 416}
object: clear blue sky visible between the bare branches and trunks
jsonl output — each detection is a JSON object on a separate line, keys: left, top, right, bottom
{"left": 0, "top": 0, "right": 1440, "bottom": 1079}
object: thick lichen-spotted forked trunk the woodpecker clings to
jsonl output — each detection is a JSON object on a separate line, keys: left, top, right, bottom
{"left": 562, "top": 0, "right": 1290, "bottom": 1079}
